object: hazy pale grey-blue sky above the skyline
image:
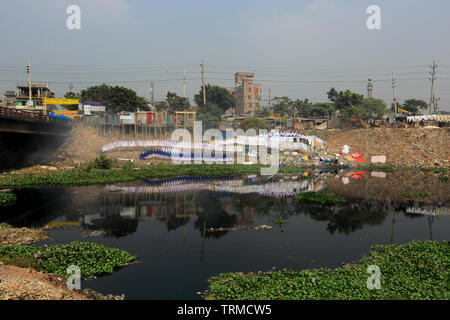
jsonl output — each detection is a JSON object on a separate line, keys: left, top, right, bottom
{"left": 0, "top": 0, "right": 450, "bottom": 110}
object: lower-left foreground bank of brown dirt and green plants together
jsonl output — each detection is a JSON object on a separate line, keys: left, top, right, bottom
{"left": 0, "top": 223, "right": 136, "bottom": 300}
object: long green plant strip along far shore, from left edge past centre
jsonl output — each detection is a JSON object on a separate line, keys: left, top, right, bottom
{"left": 0, "top": 164, "right": 299, "bottom": 187}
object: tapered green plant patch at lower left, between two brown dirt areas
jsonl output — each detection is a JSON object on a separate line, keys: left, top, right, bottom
{"left": 0, "top": 242, "right": 136, "bottom": 278}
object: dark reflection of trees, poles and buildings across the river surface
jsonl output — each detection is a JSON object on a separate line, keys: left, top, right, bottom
{"left": 4, "top": 176, "right": 449, "bottom": 241}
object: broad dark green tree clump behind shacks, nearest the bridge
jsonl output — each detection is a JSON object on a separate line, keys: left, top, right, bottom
{"left": 81, "top": 84, "right": 147, "bottom": 112}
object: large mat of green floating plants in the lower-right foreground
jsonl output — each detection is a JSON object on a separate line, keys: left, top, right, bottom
{"left": 206, "top": 241, "right": 450, "bottom": 300}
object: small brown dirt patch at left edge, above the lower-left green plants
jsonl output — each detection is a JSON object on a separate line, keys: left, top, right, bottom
{"left": 0, "top": 227, "right": 50, "bottom": 247}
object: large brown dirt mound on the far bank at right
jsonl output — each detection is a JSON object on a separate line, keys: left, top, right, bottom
{"left": 328, "top": 128, "right": 450, "bottom": 168}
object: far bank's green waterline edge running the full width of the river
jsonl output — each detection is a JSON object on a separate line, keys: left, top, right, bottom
{"left": 0, "top": 163, "right": 450, "bottom": 188}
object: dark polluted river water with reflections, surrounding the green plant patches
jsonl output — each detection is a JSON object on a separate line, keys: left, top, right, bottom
{"left": 0, "top": 171, "right": 450, "bottom": 299}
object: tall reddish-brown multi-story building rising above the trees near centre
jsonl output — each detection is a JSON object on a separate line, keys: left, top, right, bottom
{"left": 228, "top": 72, "right": 261, "bottom": 115}
